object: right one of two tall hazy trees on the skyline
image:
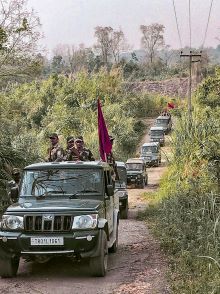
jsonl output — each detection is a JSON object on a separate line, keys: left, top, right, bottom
{"left": 140, "top": 23, "right": 164, "bottom": 63}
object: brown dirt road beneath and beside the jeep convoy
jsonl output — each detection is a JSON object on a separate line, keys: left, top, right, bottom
{"left": 0, "top": 119, "right": 169, "bottom": 294}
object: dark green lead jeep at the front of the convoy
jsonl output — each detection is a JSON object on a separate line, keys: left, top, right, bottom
{"left": 0, "top": 162, "right": 119, "bottom": 277}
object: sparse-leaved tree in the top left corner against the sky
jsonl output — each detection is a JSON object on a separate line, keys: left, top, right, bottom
{"left": 0, "top": 0, "right": 42, "bottom": 82}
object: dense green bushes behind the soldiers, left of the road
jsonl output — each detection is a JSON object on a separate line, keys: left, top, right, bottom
{"left": 0, "top": 69, "right": 166, "bottom": 203}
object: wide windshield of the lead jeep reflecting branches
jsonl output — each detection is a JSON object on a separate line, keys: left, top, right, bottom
{"left": 20, "top": 169, "right": 103, "bottom": 198}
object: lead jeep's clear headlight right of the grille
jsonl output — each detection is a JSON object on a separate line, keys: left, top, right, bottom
{"left": 72, "top": 214, "right": 98, "bottom": 229}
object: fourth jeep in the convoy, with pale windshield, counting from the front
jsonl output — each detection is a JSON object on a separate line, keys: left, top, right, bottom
{"left": 140, "top": 142, "right": 161, "bottom": 166}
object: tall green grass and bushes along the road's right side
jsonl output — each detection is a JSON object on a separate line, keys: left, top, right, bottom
{"left": 142, "top": 69, "right": 220, "bottom": 294}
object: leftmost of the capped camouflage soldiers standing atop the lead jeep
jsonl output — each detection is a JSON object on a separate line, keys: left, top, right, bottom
{"left": 47, "top": 133, "right": 64, "bottom": 162}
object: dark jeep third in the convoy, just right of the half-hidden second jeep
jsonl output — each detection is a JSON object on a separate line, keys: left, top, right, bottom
{"left": 126, "top": 158, "right": 148, "bottom": 189}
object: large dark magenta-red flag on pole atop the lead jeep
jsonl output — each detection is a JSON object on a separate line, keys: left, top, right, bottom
{"left": 98, "top": 98, "right": 112, "bottom": 161}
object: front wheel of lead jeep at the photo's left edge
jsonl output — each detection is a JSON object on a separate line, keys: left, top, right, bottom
{"left": 0, "top": 256, "right": 20, "bottom": 278}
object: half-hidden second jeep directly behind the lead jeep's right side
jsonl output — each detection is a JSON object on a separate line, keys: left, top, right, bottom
{"left": 115, "top": 161, "right": 128, "bottom": 218}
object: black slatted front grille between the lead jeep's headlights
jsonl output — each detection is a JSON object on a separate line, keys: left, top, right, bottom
{"left": 24, "top": 215, "right": 73, "bottom": 232}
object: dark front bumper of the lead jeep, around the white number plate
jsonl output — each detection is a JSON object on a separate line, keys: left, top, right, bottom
{"left": 0, "top": 229, "right": 101, "bottom": 258}
